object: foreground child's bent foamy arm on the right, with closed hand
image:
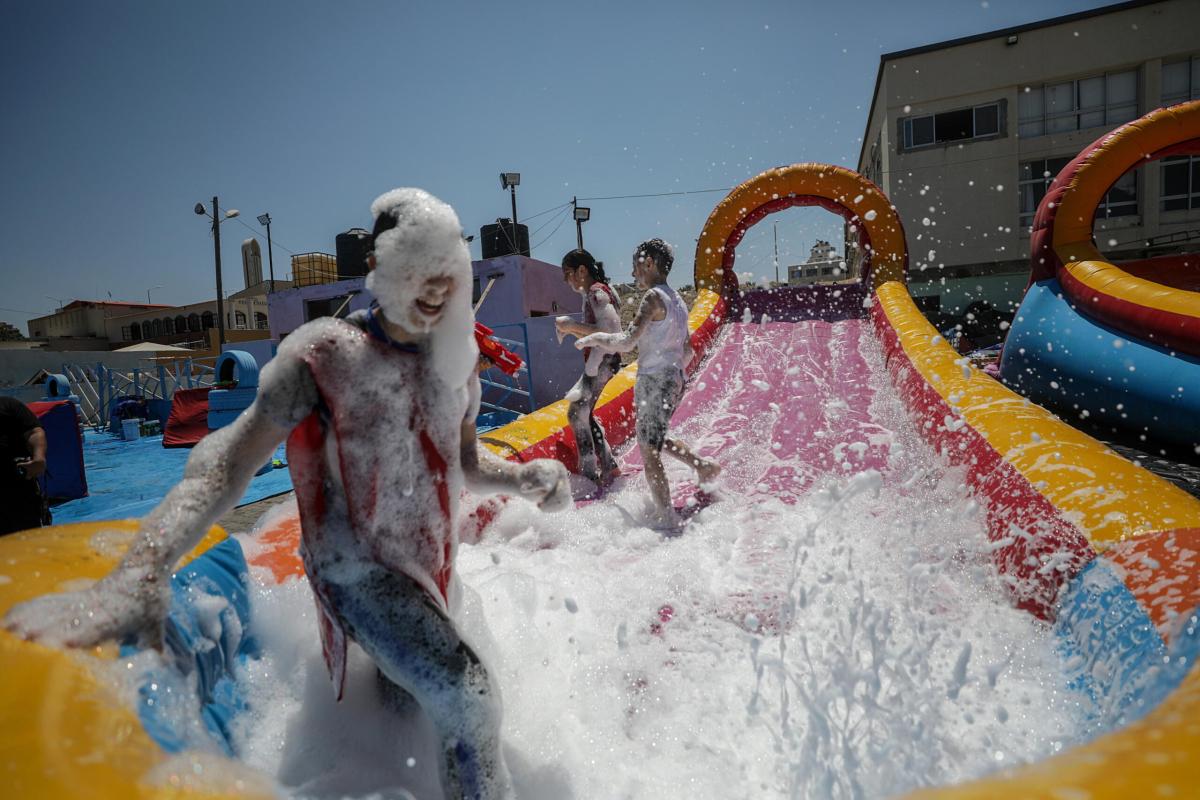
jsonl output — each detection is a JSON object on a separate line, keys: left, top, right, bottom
{"left": 460, "top": 381, "right": 571, "bottom": 511}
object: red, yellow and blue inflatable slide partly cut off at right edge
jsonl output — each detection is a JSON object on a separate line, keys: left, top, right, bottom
{"left": 1000, "top": 102, "right": 1200, "bottom": 456}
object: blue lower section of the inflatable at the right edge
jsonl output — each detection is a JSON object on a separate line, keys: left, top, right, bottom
{"left": 1000, "top": 279, "right": 1200, "bottom": 449}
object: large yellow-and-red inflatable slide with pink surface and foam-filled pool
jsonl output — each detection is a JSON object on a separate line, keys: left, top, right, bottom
{"left": 0, "top": 106, "right": 1200, "bottom": 799}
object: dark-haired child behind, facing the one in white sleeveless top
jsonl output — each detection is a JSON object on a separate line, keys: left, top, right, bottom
{"left": 554, "top": 247, "right": 620, "bottom": 489}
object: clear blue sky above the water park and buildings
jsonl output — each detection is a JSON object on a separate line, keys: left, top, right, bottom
{"left": 0, "top": 0, "right": 1108, "bottom": 332}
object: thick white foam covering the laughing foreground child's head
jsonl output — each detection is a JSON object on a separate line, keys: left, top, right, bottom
{"left": 366, "top": 188, "right": 479, "bottom": 386}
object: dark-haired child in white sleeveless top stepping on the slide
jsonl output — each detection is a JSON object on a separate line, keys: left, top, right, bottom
{"left": 575, "top": 239, "right": 721, "bottom": 529}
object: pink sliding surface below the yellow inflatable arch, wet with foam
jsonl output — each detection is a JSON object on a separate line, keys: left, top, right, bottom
{"left": 623, "top": 319, "right": 890, "bottom": 505}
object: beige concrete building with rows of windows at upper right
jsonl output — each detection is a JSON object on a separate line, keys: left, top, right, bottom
{"left": 858, "top": 0, "right": 1200, "bottom": 319}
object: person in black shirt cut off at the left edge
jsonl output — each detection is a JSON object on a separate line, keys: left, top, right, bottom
{"left": 0, "top": 397, "right": 46, "bottom": 534}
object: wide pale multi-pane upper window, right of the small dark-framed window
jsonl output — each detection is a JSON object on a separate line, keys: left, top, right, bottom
{"left": 1016, "top": 70, "right": 1138, "bottom": 137}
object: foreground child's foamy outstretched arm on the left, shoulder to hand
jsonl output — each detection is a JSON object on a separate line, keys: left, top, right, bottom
{"left": 4, "top": 349, "right": 317, "bottom": 646}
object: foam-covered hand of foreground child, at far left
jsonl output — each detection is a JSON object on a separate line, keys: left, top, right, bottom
{"left": 4, "top": 570, "right": 170, "bottom": 648}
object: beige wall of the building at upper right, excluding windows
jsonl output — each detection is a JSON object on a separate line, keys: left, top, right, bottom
{"left": 859, "top": 0, "right": 1200, "bottom": 303}
